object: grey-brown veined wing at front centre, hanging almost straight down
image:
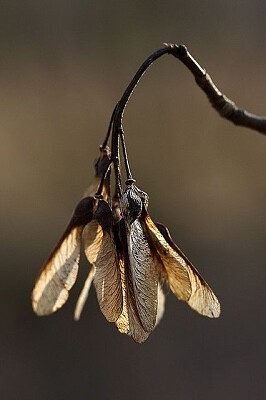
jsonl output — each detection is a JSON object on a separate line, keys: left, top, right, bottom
{"left": 127, "top": 219, "right": 158, "bottom": 332}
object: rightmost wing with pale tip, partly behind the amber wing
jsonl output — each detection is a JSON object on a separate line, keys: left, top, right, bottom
{"left": 156, "top": 220, "right": 221, "bottom": 318}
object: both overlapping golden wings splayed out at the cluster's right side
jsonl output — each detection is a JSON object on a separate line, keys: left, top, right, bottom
{"left": 145, "top": 215, "right": 220, "bottom": 318}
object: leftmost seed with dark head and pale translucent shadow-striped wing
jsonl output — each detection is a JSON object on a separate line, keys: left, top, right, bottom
{"left": 32, "top": 198, "right": 93, "bottom": 315}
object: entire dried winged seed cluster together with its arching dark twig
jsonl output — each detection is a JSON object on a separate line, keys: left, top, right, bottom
{"left": 32, "top": 45, "right": 231, "bottom": 343}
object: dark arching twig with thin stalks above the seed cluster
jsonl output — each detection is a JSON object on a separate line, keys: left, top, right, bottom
{"left": 102, "top": 44, "right": 266, "bottom": 195}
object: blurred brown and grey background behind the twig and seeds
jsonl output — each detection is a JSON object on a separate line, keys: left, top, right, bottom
{"left": 0, "top": 0, "right": 266, "bottom": 400}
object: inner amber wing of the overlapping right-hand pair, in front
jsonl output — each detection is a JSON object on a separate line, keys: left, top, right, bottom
{"left": 145, "top": 214, "right": 192, "bottom": 301}
